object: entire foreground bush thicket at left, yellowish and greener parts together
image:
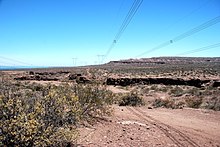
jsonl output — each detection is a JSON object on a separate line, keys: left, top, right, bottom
{"left": 0, "top": 82, "right": 111, "bottom": 146}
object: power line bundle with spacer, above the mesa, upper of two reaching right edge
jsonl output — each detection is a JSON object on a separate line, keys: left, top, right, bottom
{"left": 136, "top": 16, "right": 220, "bottom": 57}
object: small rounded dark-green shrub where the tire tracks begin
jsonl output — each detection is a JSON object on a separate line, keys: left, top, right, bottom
{"left": 119, "top": 93, "right": 144, "bottom": 106}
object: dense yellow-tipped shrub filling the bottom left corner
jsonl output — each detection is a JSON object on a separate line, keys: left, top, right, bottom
{"left": 0, "top": 83, "right": 77, "bottom": 146}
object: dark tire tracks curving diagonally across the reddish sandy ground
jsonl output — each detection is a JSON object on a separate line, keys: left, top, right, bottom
{"left": 126, "top": 107, "right": 199, "bottom": 147}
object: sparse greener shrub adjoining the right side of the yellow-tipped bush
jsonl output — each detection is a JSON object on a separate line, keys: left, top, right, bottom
{"left": 73, "top": 85, "right": 114, "bottom": 122}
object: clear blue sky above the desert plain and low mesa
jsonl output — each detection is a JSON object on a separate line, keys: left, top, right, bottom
{"left": 0, "top": 0, "right": 220, "bottom": 66}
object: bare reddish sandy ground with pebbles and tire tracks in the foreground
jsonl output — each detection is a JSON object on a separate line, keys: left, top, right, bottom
{"left": 77, "top": 106, "right": 220, "bottom": 147}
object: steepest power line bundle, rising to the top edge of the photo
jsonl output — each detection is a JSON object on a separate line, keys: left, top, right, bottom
{"left": 102, "top": 0, "right": 143, "bottom": 62}
